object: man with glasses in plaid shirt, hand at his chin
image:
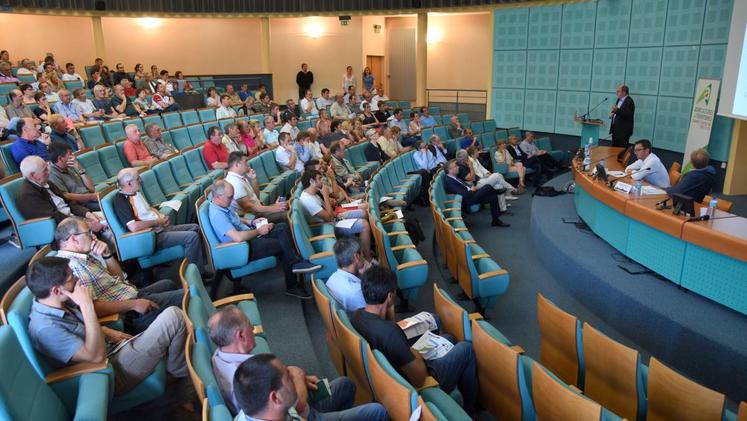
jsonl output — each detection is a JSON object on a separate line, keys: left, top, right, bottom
{"left": 54, "top": 217, "right": 184, "bottom": 333}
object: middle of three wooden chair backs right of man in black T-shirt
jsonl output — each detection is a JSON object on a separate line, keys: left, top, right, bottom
{"left": 472, "top": 320, "right": 522, "bottom": 421}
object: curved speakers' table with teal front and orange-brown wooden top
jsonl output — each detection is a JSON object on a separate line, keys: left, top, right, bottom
{"left": 572, "top": 146, "right": 747, "bottom": 314}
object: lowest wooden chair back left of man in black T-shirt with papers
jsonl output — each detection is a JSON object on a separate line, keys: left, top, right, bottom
{"left": 365, "top": 344, "right": 412, "bottom": 420}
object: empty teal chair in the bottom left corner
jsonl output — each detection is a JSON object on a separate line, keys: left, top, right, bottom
{"left": 0, "top": 326, "right": 110, "bottom": 421}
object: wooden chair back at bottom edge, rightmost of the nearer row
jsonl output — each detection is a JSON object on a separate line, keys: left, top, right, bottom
{"left": 532, "top": 363, "right": 602, "bottom": 421}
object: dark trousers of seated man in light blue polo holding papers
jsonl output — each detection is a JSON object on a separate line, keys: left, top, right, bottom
{"left": 249, "top": 222, "right": 301, "bottom": 288}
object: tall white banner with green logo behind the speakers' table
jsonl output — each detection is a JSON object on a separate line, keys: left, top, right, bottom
{"left": 682, "top": 79, "right": 721, "bottom": 174}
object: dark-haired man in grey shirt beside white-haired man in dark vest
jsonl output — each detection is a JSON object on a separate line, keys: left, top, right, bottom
{"left": 48, "top": 142, "right": 101, "bottom": 211}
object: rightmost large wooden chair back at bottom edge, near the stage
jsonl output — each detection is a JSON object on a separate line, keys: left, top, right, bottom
{"left": 646, "top": 357, "right": 726, "bottom": 421}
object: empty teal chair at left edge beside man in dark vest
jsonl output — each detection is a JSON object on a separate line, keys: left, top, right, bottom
{"left": 0, "top": 174, "right": 57, "bottom": 248}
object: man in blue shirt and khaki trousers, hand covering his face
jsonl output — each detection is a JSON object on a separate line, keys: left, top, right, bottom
{"left": 26, "top": 257, "right": 187, "bottom": 395}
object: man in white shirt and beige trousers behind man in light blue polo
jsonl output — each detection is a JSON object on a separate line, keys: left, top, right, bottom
{"left": 226, "top": 152, "right": 288, "bottom": 223}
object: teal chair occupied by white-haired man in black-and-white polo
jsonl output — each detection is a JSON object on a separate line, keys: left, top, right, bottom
{"left": 100, "top": 189, "right": 184, "bottom": 268}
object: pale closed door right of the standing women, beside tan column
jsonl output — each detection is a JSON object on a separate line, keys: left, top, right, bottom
{"left": 387, "top": 28, "right": 415, "bottom": 101}
